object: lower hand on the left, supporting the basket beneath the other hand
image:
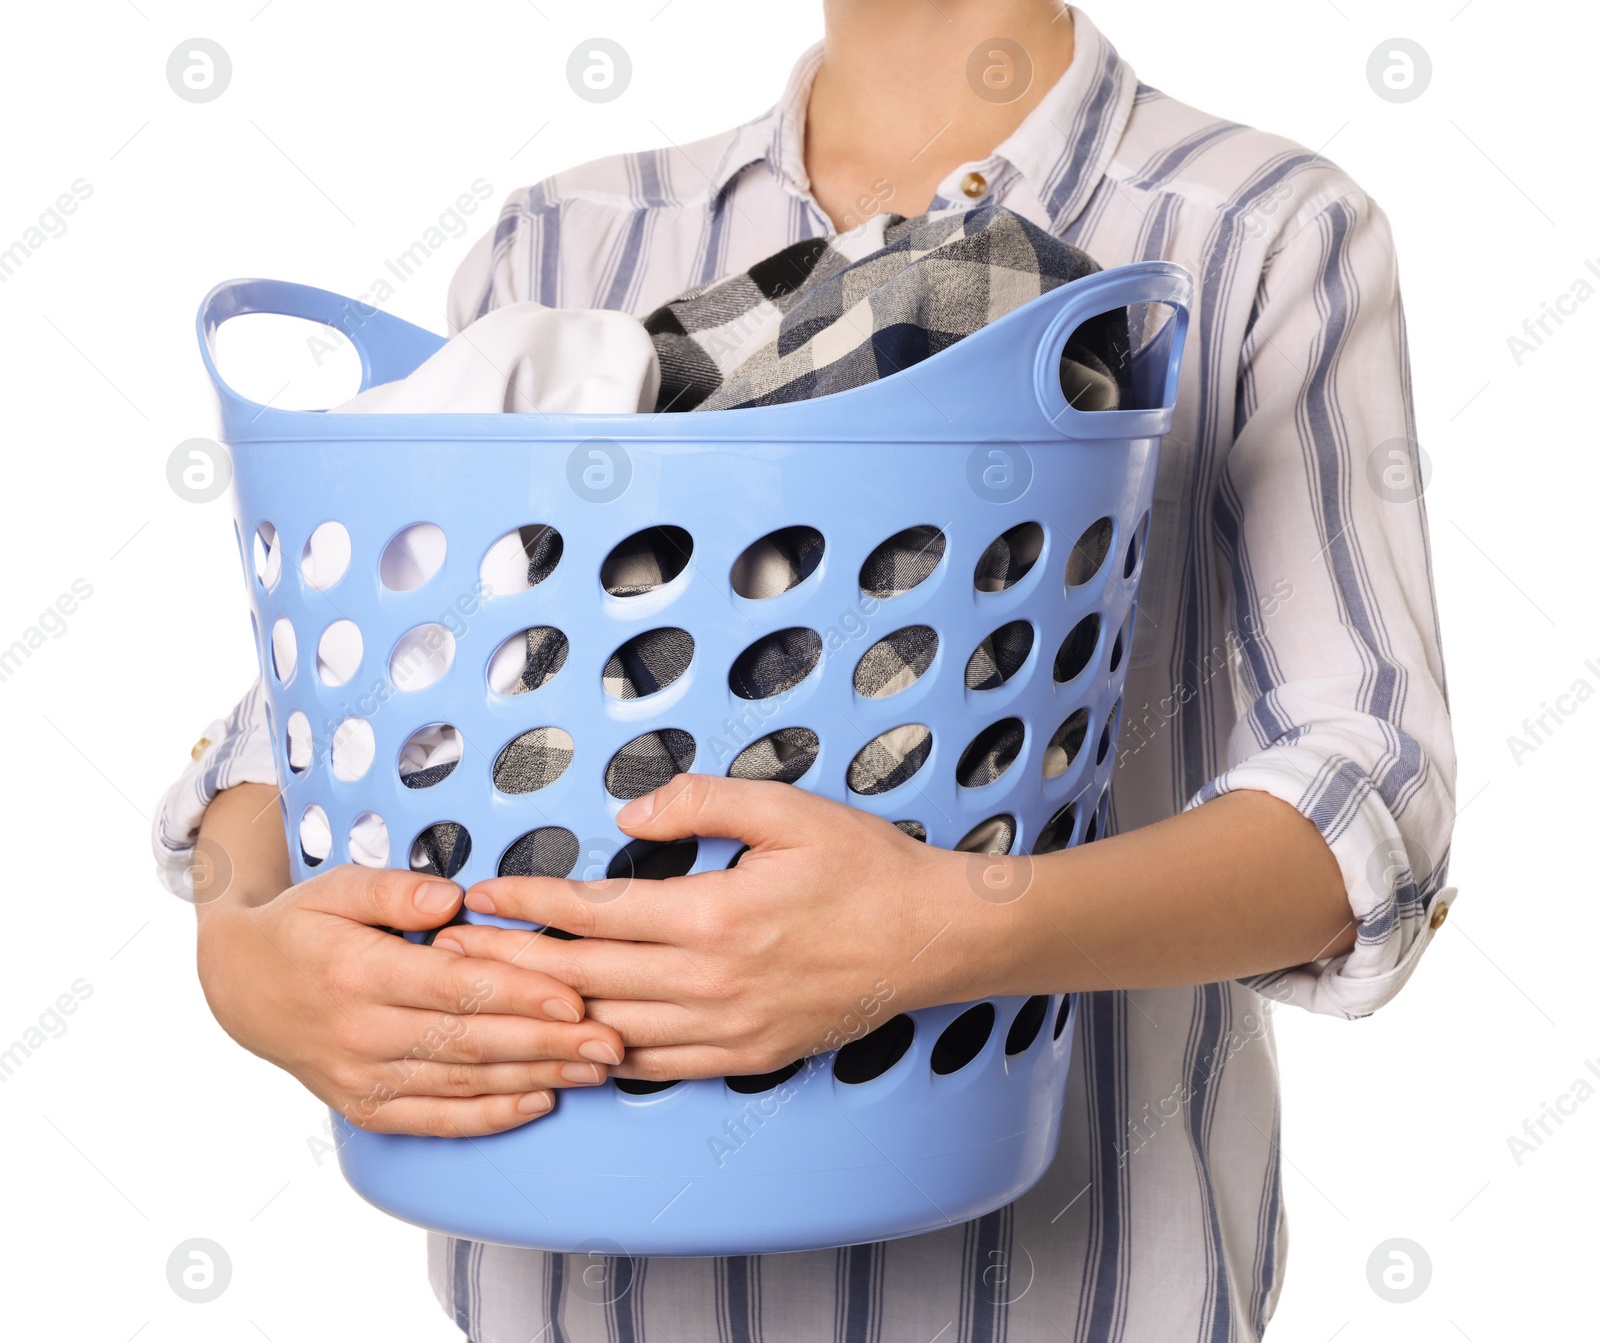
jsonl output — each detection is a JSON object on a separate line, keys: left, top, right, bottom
{"left": 197, "top": 784, "right": 622, "bottom": 1137}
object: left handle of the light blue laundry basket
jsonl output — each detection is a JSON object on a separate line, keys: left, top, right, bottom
{"left": 195, "top": 280, "right": 445, "bottom": 419}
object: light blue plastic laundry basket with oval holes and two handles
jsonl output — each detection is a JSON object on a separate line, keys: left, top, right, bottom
{"left": 198, "top": 263, "right": 1192, "bottom": 1255}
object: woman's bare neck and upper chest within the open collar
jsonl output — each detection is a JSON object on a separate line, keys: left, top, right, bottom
{"left": 805, "top": 0, "right": 1072, "bottom": 231}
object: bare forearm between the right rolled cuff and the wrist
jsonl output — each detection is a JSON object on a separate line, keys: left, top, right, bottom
{"left": 946, "top": 791, "right": 1355, "bottom": 999}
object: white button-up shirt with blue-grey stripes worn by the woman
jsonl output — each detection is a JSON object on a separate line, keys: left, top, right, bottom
{"left": 157, "top": 11, "right": 1454, "bottom": 1343}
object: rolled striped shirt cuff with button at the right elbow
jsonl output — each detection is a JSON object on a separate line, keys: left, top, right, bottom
{"left": 1189, "top": 746, "right": 1456, "bottom": 1021}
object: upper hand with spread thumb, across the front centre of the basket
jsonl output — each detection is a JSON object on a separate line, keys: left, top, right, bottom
{"left": 438, "top": 775, "right": 984, "bottom": 1080}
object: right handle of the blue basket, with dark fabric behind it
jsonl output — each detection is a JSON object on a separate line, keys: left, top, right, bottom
{"left": 1034, "top": 261, "right": 1194, "bottom": 439}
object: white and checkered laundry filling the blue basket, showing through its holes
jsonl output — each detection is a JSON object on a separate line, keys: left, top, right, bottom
{"left": 300, "top": 206, "right": 1131, "bottom": 876}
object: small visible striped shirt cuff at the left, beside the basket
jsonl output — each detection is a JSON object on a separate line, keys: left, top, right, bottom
{"left": 150, "top": 680, "right": 278, "bottom": 900}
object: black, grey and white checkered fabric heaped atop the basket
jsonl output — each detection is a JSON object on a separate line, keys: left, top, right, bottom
{"left": 645, "top": 205, "right": 1130, "bottom": 411}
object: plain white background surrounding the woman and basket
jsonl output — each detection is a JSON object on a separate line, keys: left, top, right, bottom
{"left": 0, "top": 0, "right": 1600, "bottom": 1343}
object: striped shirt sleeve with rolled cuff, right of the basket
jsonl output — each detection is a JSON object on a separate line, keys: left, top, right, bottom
{"left": 1190, "top": 192, "right": 1456, "bottom": 1018}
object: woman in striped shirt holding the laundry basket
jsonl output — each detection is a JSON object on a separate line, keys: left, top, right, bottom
{"left": 157, "top": 0, "right": 1454, "bottom": 1343}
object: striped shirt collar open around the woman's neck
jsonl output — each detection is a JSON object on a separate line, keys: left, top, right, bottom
{"left": 712, "top": 6, "right": 1139, "bottom": 232}
